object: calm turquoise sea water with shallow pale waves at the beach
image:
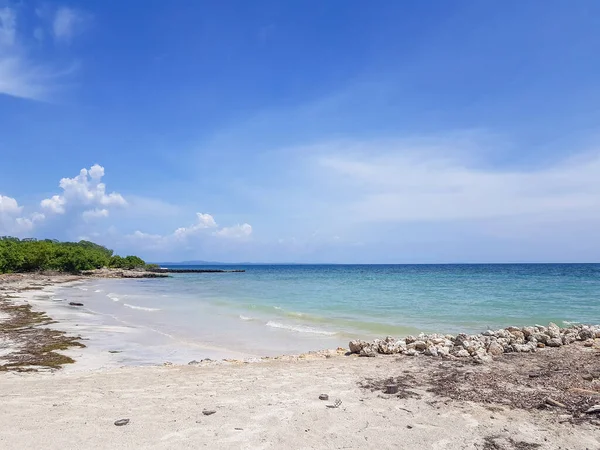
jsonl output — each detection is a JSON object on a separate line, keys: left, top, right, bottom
{"left": 56, "top": 264, "right": 600, "bottom": 362}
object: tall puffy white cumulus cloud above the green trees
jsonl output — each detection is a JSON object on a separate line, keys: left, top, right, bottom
{"left": 40, "top": 164, "right": 127, "bottom": 218}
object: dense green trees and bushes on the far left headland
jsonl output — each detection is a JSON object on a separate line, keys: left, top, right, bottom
{"left": 0, "top": 236, "right": 155, "bottom": 273}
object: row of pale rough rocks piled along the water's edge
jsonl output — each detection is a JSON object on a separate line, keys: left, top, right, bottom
{"left": 349, "top": 322, "right": 600, "bottom": 363}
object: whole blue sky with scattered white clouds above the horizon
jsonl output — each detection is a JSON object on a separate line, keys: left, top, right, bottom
{"left": 0, "top": 0, "right": 600, "bottom": 263}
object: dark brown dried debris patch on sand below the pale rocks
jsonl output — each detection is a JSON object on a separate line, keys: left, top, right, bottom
{"left": 359, "top": 343, "right": 600, "bottom": 424}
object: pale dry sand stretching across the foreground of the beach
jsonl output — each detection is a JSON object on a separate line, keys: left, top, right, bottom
{"left": 0, "top": 272, "right": 600, "bottom": 450}
